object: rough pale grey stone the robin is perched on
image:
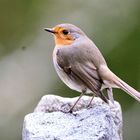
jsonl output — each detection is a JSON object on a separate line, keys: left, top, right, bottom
{"left": 22, "top": 95, "right": 122, "bottom": 140}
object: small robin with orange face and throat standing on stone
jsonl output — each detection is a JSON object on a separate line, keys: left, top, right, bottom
{"left": 44, "top": 23, "right": 140, "bottom": 112}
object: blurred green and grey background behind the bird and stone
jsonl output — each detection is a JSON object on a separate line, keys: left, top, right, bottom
{"left": 0, "top": 0, "right": 140, "bottom": 140}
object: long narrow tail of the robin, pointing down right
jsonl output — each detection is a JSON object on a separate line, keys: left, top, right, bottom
{"left": 114, "top": 76, "right": 140, "bottom": 102}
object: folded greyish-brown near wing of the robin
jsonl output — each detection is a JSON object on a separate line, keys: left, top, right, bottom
{"left": 56, "top": 49, "right": 107, "bottom": 102}
